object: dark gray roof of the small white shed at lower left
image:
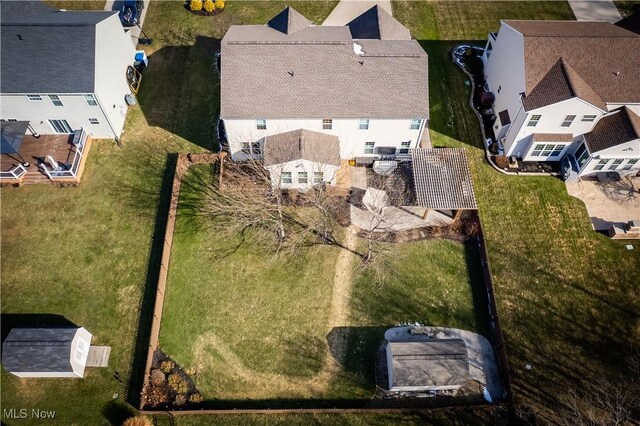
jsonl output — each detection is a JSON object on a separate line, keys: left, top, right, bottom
{"left": 2, "top": 327, "right": 79, "bottom": 372}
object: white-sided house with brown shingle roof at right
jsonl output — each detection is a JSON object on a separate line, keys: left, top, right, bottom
{"left": 482, "top": 21, "right": 640, "bottom": 176}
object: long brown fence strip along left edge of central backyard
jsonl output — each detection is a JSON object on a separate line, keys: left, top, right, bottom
{"left": 139, "top": 152, "right": 226, "bottom": 410}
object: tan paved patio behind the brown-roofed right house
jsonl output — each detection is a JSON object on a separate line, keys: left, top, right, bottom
{"left": 565, "top": 177, "right": 640, "bottom": 231}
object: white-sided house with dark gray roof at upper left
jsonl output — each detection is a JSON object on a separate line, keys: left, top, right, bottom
{"left": 0, "top": 1, "right": 135, "bottom": 138}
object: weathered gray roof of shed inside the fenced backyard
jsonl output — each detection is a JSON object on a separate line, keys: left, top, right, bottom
{"left": 389, "top": 339, "right": 470, "bottom": 388}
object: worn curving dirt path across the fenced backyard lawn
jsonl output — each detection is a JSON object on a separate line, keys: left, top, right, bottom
{"left": 193, "top": 228, "right": 358, "bottom": 397}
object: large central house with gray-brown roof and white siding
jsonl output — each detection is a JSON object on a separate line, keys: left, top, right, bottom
{"left": 220, "top": 6, "right": 429, "bottom": 186}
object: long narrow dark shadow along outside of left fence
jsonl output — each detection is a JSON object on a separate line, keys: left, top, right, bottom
{"left": 125, "top": 154, "right": 178, "bottom": 407}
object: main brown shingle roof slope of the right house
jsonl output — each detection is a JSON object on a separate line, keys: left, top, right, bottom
{"left": 504, "top": 21, "right": 640, "bottom": 106}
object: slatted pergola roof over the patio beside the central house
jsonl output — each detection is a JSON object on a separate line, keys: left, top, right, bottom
{"left": 411, "top": 148, "right": 478, "bottom": 210}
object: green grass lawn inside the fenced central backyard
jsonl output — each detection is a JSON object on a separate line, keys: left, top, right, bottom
{"left": 160, "top": 166, "right": 482, "bottom": 407}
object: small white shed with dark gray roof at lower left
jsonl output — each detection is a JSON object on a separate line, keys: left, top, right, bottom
{"left": 2, "top": 327, "right": 92, "bottom": 377}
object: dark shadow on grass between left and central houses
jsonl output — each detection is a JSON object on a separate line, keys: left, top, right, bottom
{"left": 138, "top": 36, "right": 220, "bottom": 151}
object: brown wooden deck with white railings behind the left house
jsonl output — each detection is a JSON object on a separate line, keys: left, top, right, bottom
{"left": 0, "top": 134, "right": 91, "bottom": 185}
